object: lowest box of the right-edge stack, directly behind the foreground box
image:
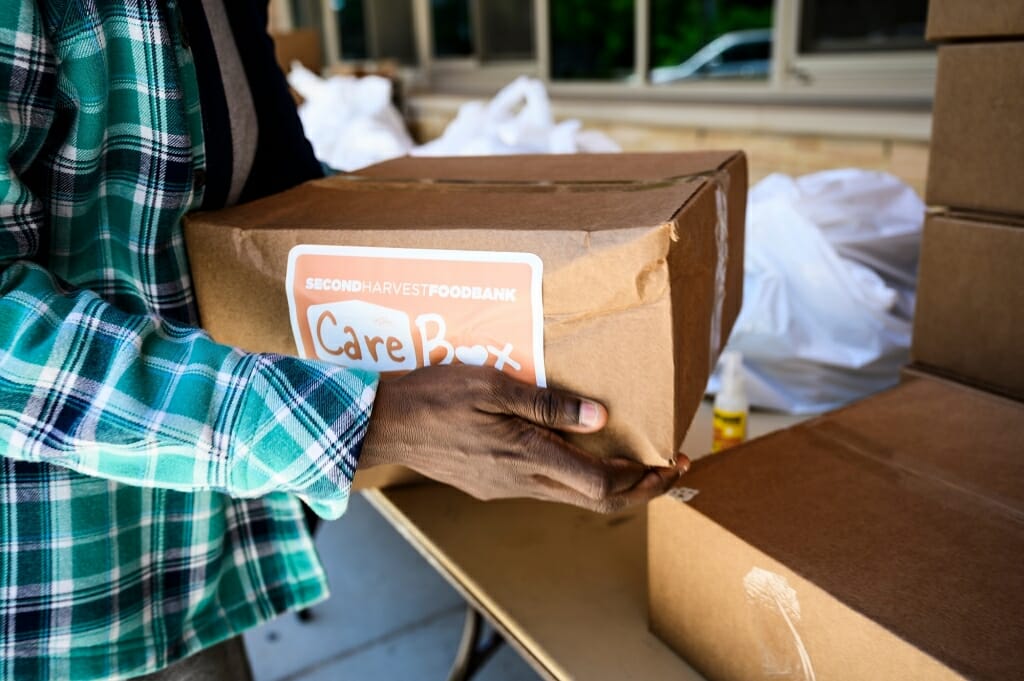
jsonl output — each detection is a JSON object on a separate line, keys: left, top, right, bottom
{"left": 910, "top": 215, "right": 1024, "bottom": 399}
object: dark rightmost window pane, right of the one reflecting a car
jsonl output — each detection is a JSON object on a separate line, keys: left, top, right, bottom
{"left": 800, "top": 0, "right": 937, "bottom": 54}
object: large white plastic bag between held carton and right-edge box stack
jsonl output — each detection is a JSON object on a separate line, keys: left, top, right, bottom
{"left": 709, "top": 169, "right": 925, "bottom": 414}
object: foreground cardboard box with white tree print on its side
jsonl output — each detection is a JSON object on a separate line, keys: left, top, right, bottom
{"left": 648, "top": 378, "right": 1024, "bottom": 681}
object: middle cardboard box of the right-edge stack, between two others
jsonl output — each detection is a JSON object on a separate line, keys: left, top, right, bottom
{"left": 926, "top": 42, "right": 1024, "bottom": 215}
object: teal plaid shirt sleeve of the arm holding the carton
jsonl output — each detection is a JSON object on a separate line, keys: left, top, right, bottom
{"left": 0, "top": 3, "right": 376, "bottom": 517}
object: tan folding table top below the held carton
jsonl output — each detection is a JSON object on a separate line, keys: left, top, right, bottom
{"left": 368, "top": 483, "right": 705, "bottom": 681}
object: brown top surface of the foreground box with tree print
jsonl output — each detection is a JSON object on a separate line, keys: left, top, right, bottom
{"left": 671, "top": 378, "right": 1024, "bottom": 679}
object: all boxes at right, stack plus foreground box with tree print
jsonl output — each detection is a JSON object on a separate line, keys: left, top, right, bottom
{"left": 648, "top": 0, "right": 1024, "bottom": 681}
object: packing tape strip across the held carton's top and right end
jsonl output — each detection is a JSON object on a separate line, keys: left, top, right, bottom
{"left": 331, "top": 170, "right": 729, "bottom": 372}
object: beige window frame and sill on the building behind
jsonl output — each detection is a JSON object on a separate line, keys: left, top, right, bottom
{"left": 323, "top": 0, "right": 936, "bottom": 106}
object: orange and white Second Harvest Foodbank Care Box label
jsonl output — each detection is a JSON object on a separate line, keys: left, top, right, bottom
{"left": 287, "top": 245, "right": 546, "bottom": 386}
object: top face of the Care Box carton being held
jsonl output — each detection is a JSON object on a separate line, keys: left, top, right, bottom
{"left": 189, "top": 152, "right": 737, "bottom": 231}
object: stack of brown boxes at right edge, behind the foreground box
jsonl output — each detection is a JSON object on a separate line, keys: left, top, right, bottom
{"left": 911, "top": 0, "right": 1024, "bottom": 399}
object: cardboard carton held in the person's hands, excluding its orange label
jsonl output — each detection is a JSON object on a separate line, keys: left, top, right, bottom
{"left": 185, "top": 152, "right": 746, "bottom": 477}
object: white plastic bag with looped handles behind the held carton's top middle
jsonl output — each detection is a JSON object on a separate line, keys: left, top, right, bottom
{"left": 413, "top": 77, "right": 622, "bottom": 156}
